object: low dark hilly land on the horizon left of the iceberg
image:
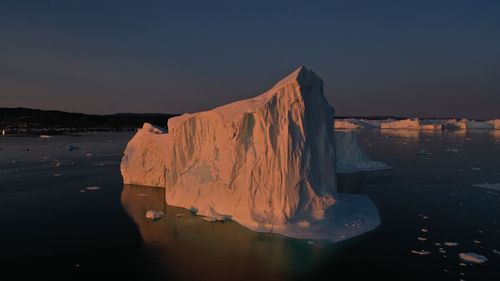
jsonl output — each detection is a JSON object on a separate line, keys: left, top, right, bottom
{"left": 0, "top": 107, "right": 178, "bottom": 134}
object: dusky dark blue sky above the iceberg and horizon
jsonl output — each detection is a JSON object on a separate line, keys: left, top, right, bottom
{"left": 0, "top": 0, "right": 500, "bottom": 118}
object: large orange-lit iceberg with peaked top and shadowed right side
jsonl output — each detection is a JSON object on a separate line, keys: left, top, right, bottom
{"left": 121, "top": 67, "right": 380, "bottom": 241}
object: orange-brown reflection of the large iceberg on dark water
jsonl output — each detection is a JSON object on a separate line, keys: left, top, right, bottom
{"left": 121, "top": 185, "right": 331, "bottom": 280}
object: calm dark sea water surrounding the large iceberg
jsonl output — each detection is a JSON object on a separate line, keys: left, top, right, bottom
{"left": 0, "top": 131, "right": 500, "bottom": 280}
